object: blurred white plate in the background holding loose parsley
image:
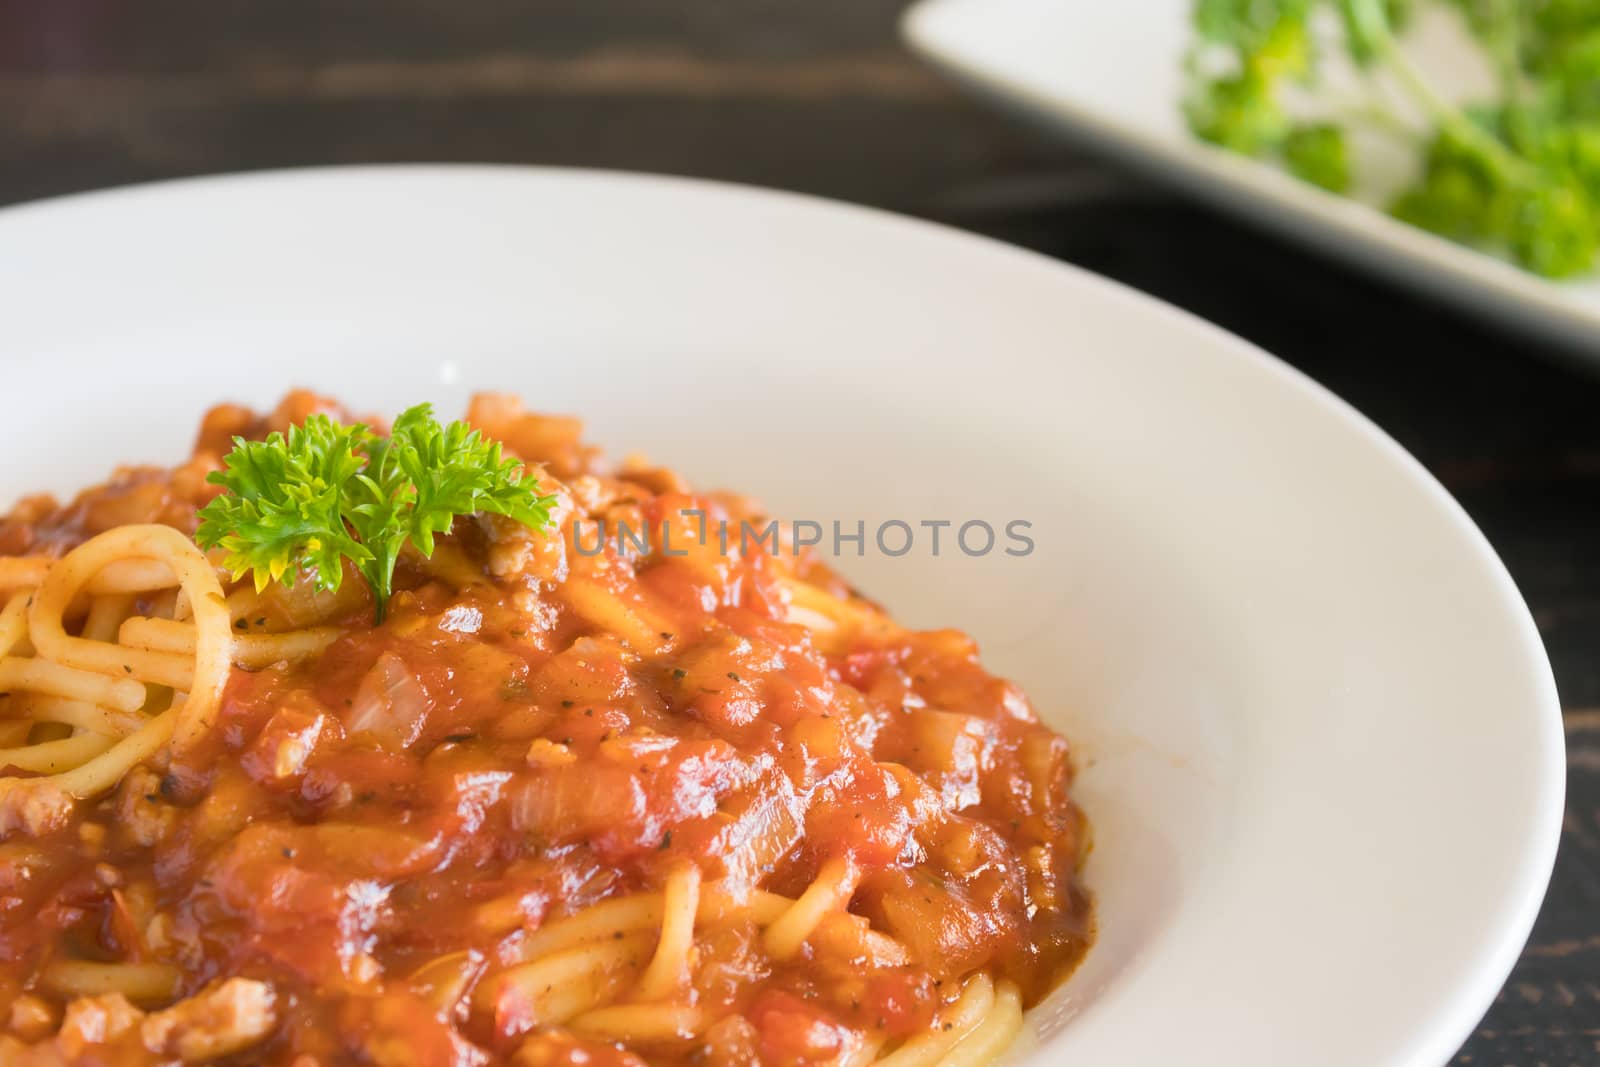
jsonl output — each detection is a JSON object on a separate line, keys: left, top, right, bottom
{"left": 902, "top": 0, "right": 1600, "bottom": 358}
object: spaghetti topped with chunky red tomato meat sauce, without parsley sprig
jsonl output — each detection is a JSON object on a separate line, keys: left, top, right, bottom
{"left": 0, "top": 394, "right": 1090, "bottom": 1067}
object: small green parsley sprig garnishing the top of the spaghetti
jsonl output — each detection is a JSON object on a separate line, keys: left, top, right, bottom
{"left": 195, "top": 403, "right": 555, "bottom": 622}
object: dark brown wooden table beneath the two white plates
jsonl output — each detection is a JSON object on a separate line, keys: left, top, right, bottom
{"left": 0, "top": 0, "right": 1600, "bottom": 1067}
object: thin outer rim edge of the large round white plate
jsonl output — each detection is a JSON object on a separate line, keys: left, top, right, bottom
{"left": 0, "top": 163, "right": 1566, "bottom": 1062}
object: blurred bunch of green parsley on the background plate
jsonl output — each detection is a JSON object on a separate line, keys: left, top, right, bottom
{"left": 1184, "top": 0, "right": 1600, "bottom": 278}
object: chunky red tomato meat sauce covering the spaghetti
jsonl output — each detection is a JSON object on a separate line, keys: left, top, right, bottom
{"left": 0, "top": 395, "right": 1090, "bottom": 1067}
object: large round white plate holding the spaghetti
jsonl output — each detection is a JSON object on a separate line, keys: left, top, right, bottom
{"left": 0, "top": 168, "right": 1563, "bottom": 1067}
